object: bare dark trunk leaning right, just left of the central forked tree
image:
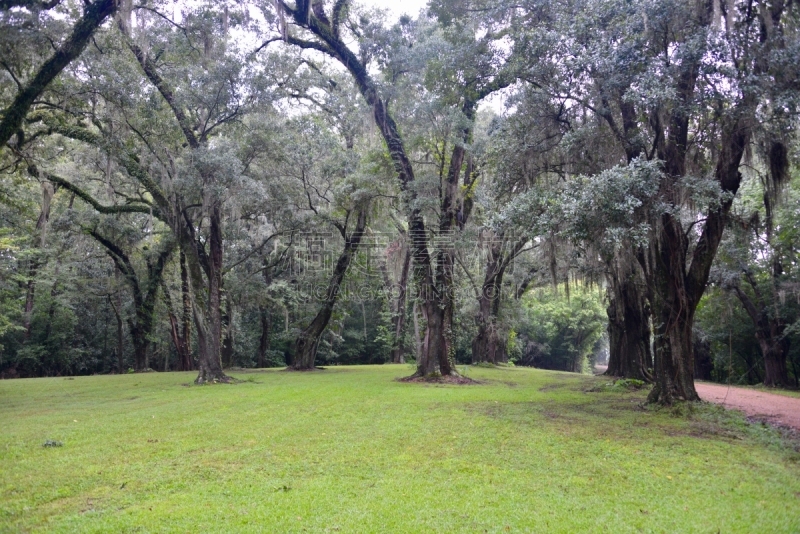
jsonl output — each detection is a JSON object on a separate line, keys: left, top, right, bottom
{"left": 291, "top": 208, "right": 367, "bottom": 371}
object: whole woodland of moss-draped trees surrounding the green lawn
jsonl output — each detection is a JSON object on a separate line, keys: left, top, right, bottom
{"left": 0, "top": 0, "right": 800, "bottom": 404}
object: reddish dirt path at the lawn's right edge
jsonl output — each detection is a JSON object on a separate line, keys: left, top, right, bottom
{"left": 694, "top": 382, "right": 800, "bottom": 430}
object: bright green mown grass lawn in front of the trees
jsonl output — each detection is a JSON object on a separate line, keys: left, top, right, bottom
{"left": 0, "top": 365, "right": 800, "bottom": 533}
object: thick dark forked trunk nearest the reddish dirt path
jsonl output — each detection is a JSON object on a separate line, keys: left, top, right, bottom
{"left": 642, "top": 33, "right": 756, "bottom": 405}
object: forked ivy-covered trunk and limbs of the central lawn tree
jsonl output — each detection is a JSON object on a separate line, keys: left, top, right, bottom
{"left": 272, "top": 0, "right": 511, "bottom": 384}
